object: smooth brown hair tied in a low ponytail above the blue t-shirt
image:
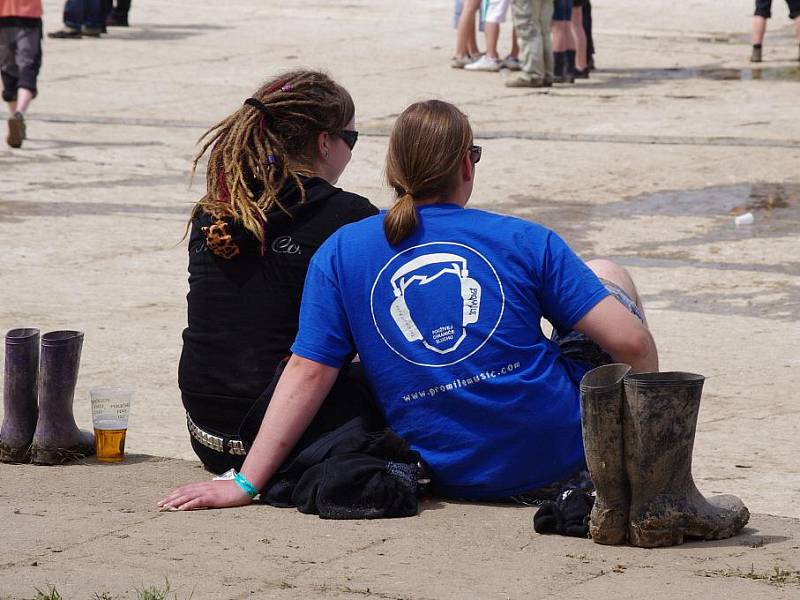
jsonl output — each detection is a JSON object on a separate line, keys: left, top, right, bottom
{"left": 383, "top": 100, "right": 472, "bottom": 245}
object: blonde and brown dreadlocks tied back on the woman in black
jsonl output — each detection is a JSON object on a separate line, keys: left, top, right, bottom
{"left": 192, "top": 71, "right": 355, "bottom": 244}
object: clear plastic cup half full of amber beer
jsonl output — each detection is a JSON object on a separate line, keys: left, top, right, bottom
{"left": 89, "top": 388, "right": 133, "bottom": 462}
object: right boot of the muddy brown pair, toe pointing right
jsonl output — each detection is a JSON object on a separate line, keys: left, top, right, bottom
{"left": 623, "top": 373, "right": 750, "bottom": 548}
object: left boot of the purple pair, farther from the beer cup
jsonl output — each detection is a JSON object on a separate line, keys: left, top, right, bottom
{"left": 0, "top": 328, "right": 39, "bottom": 463}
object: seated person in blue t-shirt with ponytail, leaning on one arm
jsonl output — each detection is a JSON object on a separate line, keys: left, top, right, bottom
{"left": 160, "top": 100, "right": 658, "bottom": 509}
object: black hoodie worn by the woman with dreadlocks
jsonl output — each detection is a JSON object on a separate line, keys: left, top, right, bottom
{"left": 178, "top": 177, "right": 378, "bottom": 434}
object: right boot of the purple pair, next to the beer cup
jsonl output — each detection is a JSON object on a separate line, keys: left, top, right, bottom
{"left": 31, "top": 331, "right": 94, "bottom": 465}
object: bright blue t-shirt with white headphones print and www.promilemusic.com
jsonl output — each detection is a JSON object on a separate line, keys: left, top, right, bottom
{"left": 292, "top": 204, "right": 608, "bottom": 499}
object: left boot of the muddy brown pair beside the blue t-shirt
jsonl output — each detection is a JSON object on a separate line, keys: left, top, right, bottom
{"left": 581, "top": 363, "right": 631, "bottom": 545}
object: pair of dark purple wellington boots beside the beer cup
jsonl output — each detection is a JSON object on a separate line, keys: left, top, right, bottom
{"left": 0, "top": 328, "right": 94, "bottom": 465}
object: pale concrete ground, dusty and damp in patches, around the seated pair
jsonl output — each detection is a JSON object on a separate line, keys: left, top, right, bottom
{"left": 0, "top": 0, "right": 800, "bottom": 599}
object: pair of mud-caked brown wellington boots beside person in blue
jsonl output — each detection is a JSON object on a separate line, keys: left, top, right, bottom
{"left": 580, "top": 364, "right": 750, "bottom": 548}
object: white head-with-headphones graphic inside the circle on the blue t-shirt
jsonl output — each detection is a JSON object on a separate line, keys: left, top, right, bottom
{"left": 389, "top": 252, "right": 481, "bottom": 354}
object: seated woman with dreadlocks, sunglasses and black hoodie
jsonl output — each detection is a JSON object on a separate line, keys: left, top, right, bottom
{"left": 178, "top": 71, "right": 378, "bottom": 473}
